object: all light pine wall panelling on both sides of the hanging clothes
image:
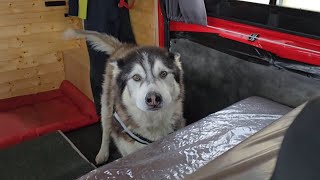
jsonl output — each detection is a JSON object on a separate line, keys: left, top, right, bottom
{"left": 0, "top": 0, "right": 158, "bottom": 99}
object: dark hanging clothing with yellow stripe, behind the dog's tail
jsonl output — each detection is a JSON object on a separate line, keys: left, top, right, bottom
{"left": 69, "top": 0, "right": 136, "bottom": 115}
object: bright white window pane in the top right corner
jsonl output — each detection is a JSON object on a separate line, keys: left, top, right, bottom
{"left": 277, "top": 0, "right": 320, "bottom": 12}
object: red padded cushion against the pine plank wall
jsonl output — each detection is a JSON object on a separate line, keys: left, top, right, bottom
{"left": 0, "top": 81, "right": 99, "bottom": 148}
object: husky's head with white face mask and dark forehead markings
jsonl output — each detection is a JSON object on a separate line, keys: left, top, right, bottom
{"left": 112, "top": 47, "right": 182, "bottom": 112}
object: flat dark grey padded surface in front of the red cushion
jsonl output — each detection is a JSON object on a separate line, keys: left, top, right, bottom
{"left": 0, "top": 132, "right": 94, "bottom": 180}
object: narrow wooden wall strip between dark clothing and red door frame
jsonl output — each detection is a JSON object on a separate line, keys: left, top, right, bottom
{"left": 129, "top": 0, "right": 158, "bottom": 45}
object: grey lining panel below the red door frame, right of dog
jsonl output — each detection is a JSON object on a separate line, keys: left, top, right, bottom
{"left": 171, "top": 39, "right": 320, "bottom": 123}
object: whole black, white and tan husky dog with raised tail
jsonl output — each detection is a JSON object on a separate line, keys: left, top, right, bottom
{"left": 65, "top": 30, "right": 185, "bottom": 164}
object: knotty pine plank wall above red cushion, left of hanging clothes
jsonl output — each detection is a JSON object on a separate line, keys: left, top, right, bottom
{"left": 0, "top": 0, "right": 85, "bottom": 99}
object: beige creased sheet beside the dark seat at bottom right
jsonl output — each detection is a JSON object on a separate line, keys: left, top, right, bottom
{"left": 184, "top": 103, "right": 306, "bottom": 180}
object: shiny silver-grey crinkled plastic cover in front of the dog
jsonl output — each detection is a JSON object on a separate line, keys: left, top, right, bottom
{"left": 80, "top": 97, "right": 291, "bottom": 180}
